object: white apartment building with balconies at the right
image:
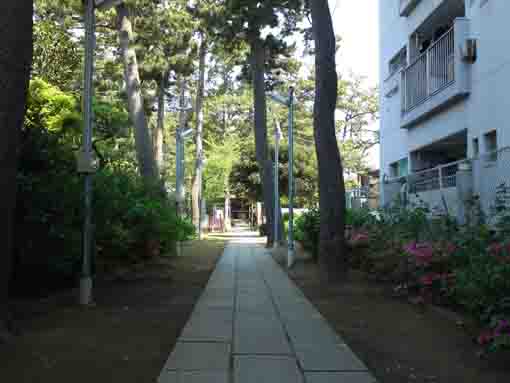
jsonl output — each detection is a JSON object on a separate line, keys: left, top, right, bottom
{"left": 379, "top": 0, "right": 510, "bottom": 218}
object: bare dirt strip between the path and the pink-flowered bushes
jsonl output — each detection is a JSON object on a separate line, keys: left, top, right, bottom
{"left": 275, "top": 256, "right": 510, "bottom": 383}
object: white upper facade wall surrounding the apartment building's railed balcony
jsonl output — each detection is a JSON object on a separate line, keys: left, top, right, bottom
{"left": 380, "top": 0, "right": 510, "bottom": 174}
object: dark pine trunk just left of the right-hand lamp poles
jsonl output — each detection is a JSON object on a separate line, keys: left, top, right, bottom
{"left": 251, "top": 39, "right": 274, "bottom": 246}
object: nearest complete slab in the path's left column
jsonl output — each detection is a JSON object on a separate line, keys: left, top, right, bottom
{"left": 164, "top": 342, "right": 230, "bottom": 371}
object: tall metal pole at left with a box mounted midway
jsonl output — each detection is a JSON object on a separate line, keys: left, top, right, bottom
{"left": 80, "top": 0, "right": 96, "bottom": 305}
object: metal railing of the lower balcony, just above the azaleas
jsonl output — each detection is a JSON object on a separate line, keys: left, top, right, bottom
{"left": 407, "top": 160, "right": 467, "bottom": 194}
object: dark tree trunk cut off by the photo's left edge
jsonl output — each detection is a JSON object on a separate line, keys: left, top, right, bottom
{"left": 0, "top": 0, "right": 33, "bottom": 343}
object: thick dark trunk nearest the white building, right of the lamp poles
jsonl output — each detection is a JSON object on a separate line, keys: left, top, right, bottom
{"left": 310, "top": 0, "right": 348, "bottom": 279}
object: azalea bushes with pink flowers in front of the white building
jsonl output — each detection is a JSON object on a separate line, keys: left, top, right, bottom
{"left": 347, "top": 196, "right": 510, "bottom": 351}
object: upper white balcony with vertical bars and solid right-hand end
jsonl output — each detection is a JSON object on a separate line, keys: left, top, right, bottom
{"left": 400, "top": 18, "right": 470, "bottom": 128}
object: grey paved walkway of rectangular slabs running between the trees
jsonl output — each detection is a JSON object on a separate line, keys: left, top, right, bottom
{"left": 158, "top": 233, "right": 375, "bottom": 383}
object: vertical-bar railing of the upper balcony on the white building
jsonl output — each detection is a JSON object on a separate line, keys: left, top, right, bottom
{"left": 402, "top": 28, "right": 455, "bottom": 114}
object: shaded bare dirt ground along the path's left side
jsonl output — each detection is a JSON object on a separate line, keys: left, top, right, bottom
{"left": 0, "top": 240, "right": 225, "bottom": 383}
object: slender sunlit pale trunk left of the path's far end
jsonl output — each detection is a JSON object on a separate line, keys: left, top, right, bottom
{"left": 191, "top": 36, "right": 207, "bottom": 231}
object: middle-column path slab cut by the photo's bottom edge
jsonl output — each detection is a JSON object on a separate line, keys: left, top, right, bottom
{"left": 234, "top": 356, "right": 304, "bottom": 383}
